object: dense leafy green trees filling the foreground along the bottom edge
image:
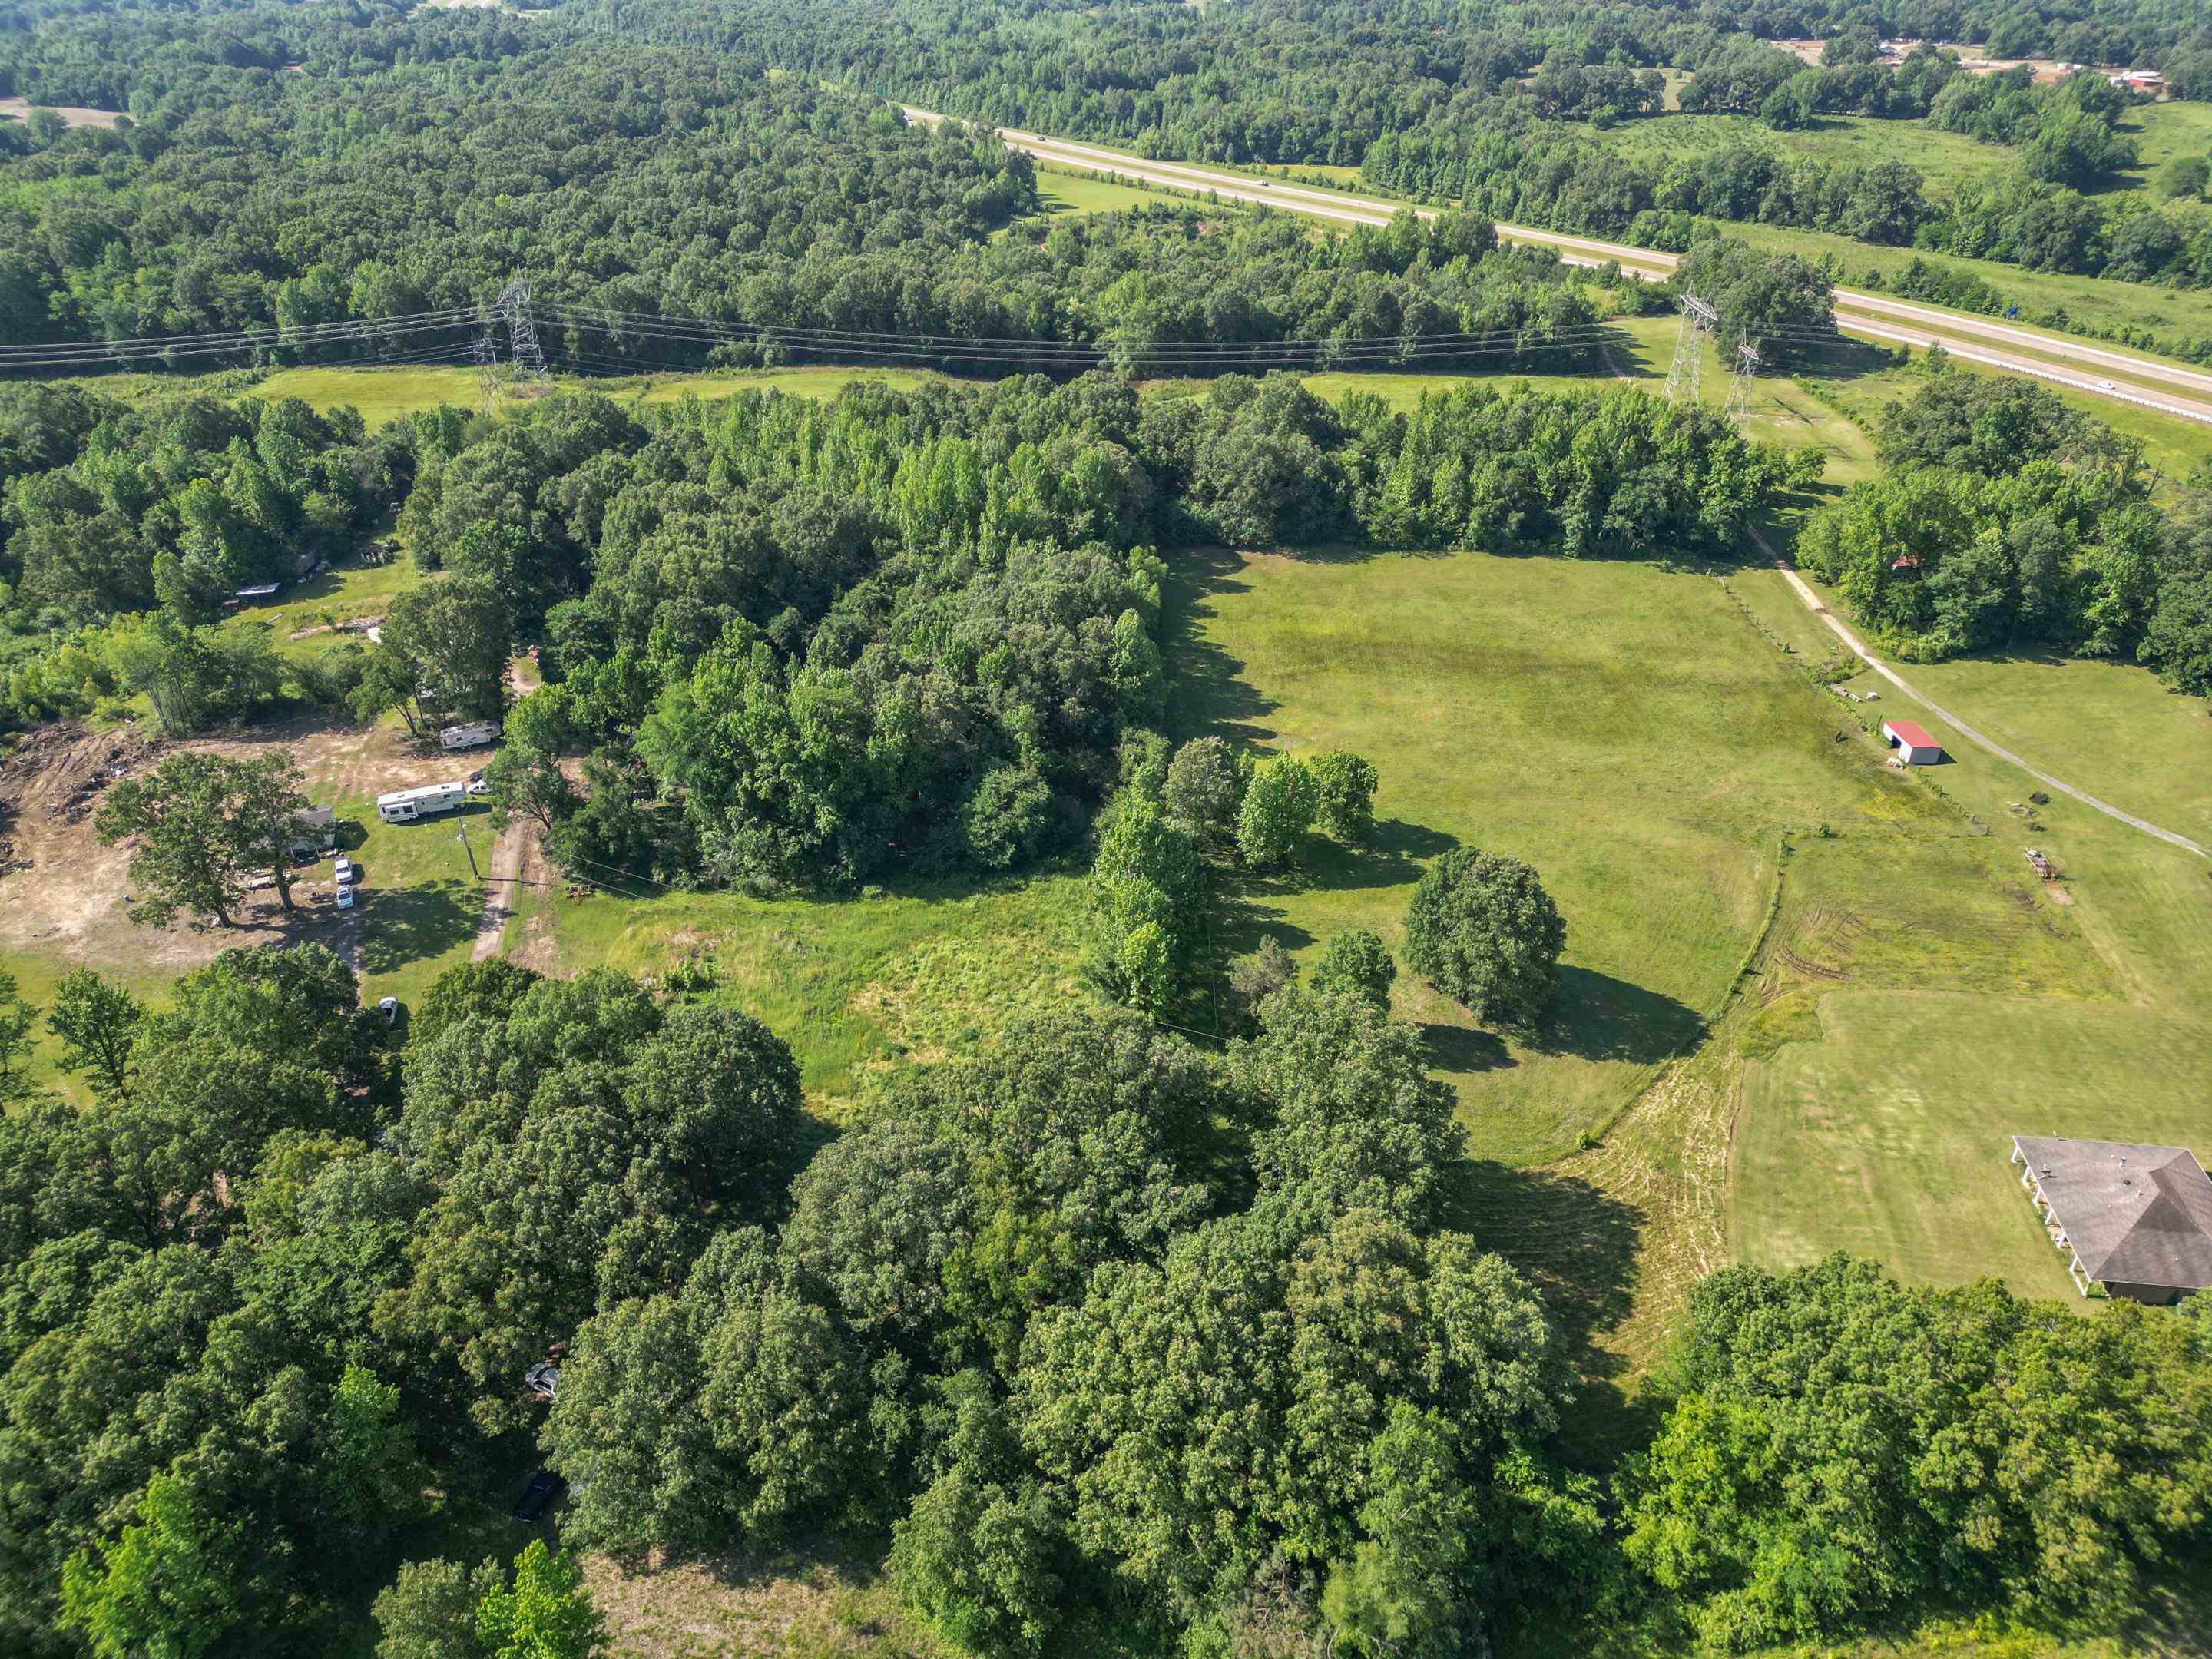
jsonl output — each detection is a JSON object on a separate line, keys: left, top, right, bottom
{"left": 0, "top": 942, "right": 2212, "bottom": 1659}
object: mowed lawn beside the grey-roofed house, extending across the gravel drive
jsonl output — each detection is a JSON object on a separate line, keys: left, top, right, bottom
{"left": 1730, "top": 571, "right": 2212, "bottom": 1307}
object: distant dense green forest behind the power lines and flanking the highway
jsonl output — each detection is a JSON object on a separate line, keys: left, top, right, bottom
{"left": 0, "top": 0, "right": 2212, "bottom": 352}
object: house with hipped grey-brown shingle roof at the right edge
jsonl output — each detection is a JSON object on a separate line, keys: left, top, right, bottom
{"left": 2013, "top": 1134, "right": 2212, "bottom": 1303}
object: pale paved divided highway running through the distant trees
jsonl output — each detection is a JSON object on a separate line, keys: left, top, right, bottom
{"left": 900, "top": 104, "right": 2212, "bottom": 425}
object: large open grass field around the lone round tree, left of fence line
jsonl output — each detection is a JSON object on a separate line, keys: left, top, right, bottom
{"left": 1171, "top": 553, "right": 2019, "bottom": 1164}
